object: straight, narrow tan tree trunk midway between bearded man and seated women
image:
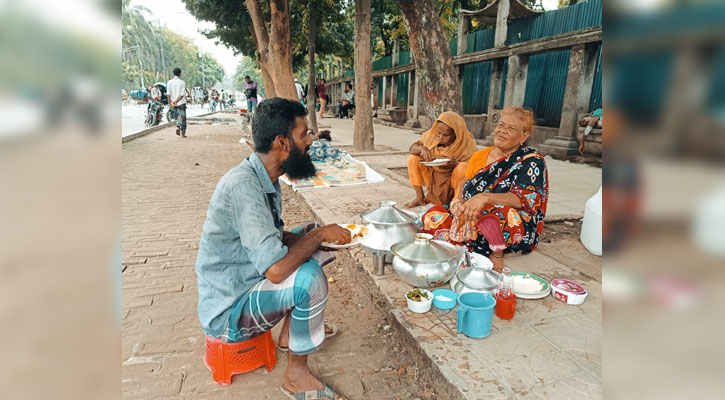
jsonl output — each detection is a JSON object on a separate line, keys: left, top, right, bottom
{"left": 353, "top": 0, "right": 375, "bottom": 151}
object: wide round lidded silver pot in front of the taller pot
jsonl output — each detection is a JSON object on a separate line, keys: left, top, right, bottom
{"left": 391, "top": 233, "right": 462, "bottom": 288}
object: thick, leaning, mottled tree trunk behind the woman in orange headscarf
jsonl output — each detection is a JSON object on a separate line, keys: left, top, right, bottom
{"left": 397, "top": 0, "right": 463, "bottom": 128}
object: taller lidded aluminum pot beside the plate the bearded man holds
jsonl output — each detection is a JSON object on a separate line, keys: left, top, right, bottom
{"left": 360, "top": 200, "right": 418, "bottom": 263}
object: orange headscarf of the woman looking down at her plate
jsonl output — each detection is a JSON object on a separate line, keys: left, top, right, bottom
{"left": 420, "top": 111, "right": 478, "bottom": 163}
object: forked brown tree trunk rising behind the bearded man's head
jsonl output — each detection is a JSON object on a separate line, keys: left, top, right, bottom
{"left": 245, "top": 0, "right": 298, "bottom": 100}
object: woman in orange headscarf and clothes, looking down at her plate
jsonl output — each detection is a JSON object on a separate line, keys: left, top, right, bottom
{"left": 405, "top": 111, "right": 478, "bottom": 208}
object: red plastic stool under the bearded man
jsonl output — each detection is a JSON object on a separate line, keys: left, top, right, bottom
{"left": 204, "top": 331, "right": 277, "bottom": 385}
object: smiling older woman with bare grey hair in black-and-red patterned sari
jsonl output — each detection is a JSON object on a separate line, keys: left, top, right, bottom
{"left": 436, "top": 107, "right": 549, "bottom": 272}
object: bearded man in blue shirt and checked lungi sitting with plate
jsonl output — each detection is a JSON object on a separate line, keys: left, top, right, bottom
{"left": 196, "top": 98, "right": 352, "bottom": 399}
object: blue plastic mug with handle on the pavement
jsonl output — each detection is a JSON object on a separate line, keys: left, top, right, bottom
{"left": 457, "top": 293, "right": 496, "bottom": 339}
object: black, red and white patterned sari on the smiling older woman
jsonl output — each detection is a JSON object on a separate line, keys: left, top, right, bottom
{"left": 458, "top": 146, "right": 549, "bottom": 255}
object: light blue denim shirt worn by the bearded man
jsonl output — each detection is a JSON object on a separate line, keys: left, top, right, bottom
{"left": 196, "top": 153, "right": 287, "bottom": 337}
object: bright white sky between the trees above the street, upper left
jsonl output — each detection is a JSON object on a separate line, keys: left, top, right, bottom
{"left": 131, "top": 0, "right": 242, "bottom": 74}
